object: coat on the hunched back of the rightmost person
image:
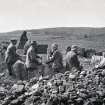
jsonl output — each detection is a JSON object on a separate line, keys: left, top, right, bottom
{"left": 65, "top": 51, "right": 80, "bottom": 70}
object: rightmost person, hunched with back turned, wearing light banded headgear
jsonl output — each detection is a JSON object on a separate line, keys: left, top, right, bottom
{"left": 65, "top": 45, "right": 81, "bottom": 71}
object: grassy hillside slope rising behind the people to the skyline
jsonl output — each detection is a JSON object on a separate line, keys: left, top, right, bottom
{"left": 0, "top": 27, "right": 105, "bottom": 50}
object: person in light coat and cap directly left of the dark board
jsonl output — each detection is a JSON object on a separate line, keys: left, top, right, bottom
{"left": 25, "top": 41, "right": 41, "bottom": 79}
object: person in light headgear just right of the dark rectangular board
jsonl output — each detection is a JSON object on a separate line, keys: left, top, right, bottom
{"left": 46, "top": 43, "right": 63, "bottom": 73}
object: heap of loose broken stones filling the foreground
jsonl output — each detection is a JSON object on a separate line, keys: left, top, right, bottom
{"left": 0, "top": 69, "right": 105, "bottom": 105}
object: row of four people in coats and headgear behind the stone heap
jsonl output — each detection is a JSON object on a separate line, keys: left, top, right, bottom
{"left": 5, "top": 39, "right": 81, "bottom": 78}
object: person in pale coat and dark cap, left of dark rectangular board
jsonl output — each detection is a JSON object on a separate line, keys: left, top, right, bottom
{"left": 25, "top": 41, "right": 43, "bottom": 79}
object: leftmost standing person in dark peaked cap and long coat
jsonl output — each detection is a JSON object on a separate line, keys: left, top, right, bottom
{"left": 5, "top": 39, "right": 19, "bottom": 75}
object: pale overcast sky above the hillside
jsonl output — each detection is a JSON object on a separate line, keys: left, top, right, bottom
{"left": 0, "top": 0, "right": 105, "bottom": 32}
